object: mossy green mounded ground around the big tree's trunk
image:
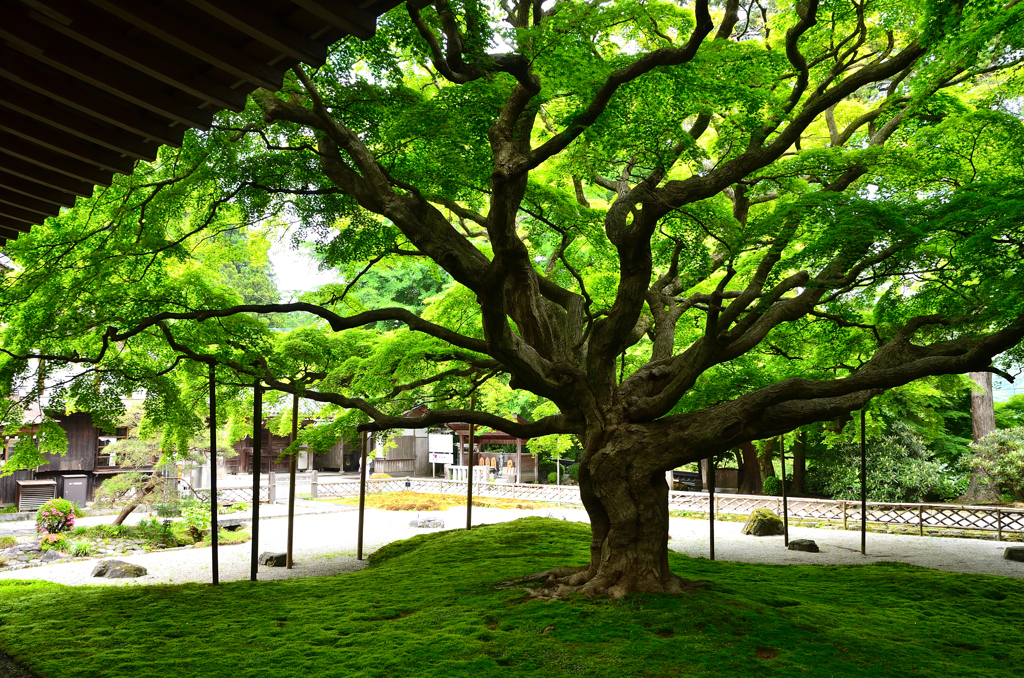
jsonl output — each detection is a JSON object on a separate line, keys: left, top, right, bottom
{"left": 0, "top": 518, "right": 1024, "bottom": 678}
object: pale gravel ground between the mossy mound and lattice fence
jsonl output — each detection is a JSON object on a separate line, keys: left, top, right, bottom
{"left": 0, "top": 507, "right": 1024, "bottom": 586}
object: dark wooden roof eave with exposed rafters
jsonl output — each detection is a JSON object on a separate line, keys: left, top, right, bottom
{"left": 0, "top": 0, "right": 401, "bottom": 246}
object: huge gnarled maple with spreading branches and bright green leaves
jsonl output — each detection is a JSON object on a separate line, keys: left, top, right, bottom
{"left": 0, "top": 0, "right": 1024, "bottom": 596}
